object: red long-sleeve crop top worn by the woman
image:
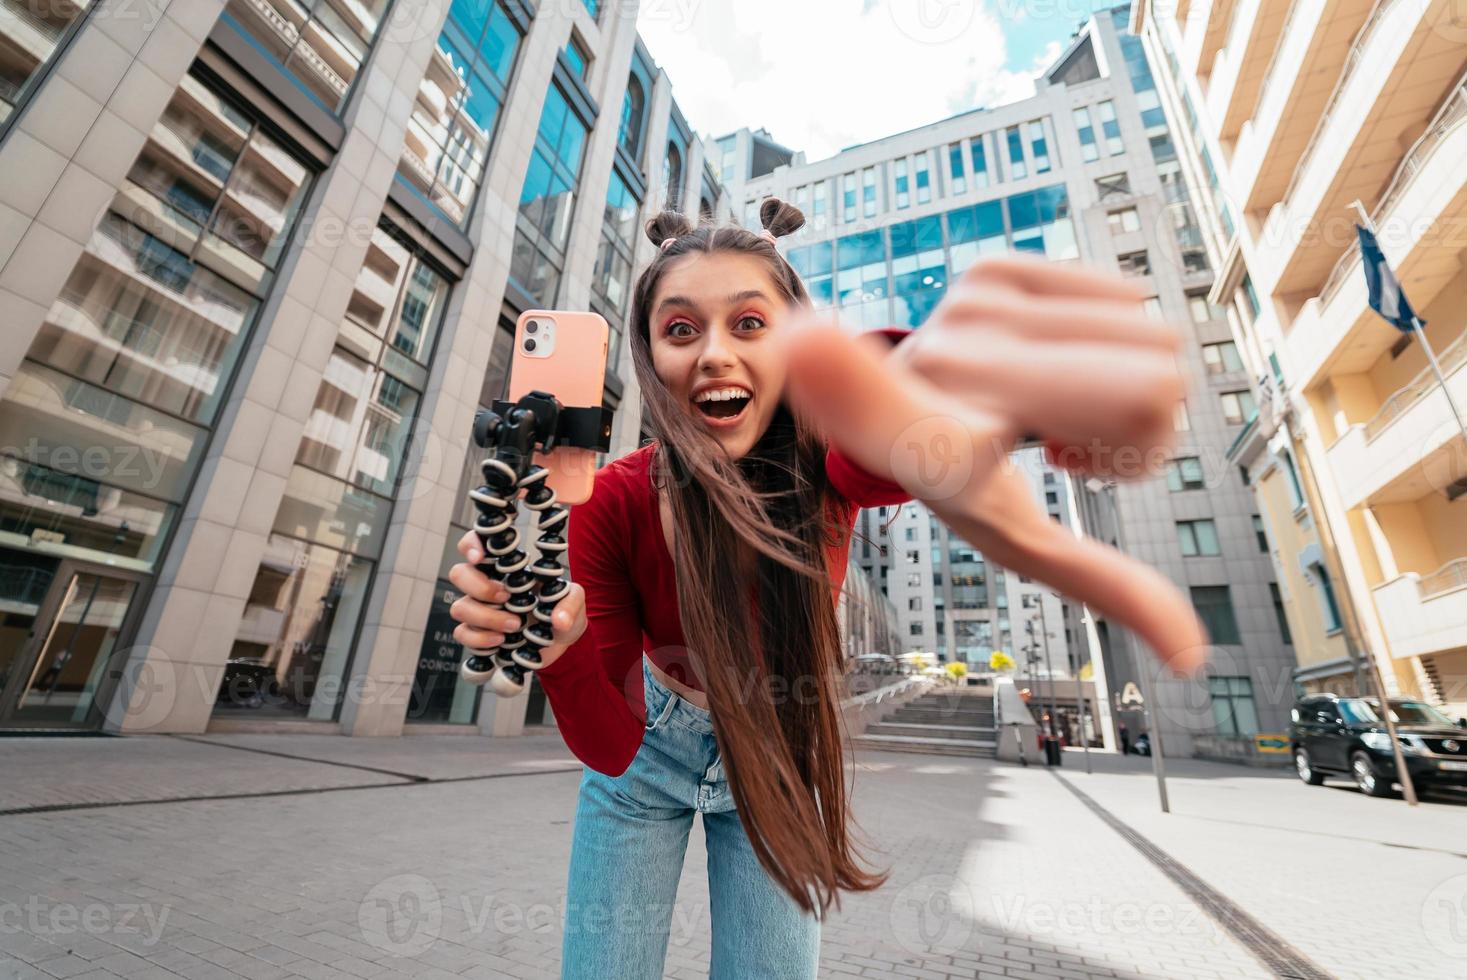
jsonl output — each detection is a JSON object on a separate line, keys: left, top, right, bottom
{"left": 537, "top": 329, "right": 911, "bottom": 776}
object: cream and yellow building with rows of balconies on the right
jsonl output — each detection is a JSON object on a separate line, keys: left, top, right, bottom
{"left": 1134, "top": 0, "right": 1467, "bottom": 717}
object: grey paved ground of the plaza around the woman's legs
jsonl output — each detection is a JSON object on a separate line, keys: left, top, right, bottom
{"left": 0, "top": 731, "right": 1467, "bottom": 980}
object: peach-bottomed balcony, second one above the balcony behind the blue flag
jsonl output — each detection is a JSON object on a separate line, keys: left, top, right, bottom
{"left": 1231, "top": 0, "right": 1375, "bottom": 211}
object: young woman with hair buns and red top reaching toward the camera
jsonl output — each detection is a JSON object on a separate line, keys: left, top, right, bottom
{"left": 450, "top": 200, "right": 1206, "bottom": 980}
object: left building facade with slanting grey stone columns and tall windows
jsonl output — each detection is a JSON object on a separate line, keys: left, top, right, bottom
{"left": 0, "top": 0, "right": 745, "bottom": 735}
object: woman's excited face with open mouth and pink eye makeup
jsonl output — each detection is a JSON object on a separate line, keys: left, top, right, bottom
{"left": 648, "top": 251, "right": 789, "bottom": 459}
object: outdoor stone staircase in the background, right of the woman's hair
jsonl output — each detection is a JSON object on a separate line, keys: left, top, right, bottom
{"left": 851, "top": 688, "right": 998, "bottom": 758}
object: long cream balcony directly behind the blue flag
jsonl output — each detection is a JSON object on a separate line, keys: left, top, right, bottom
{"left": 1285, "top": 76, "right": 1467, "bottom": 392}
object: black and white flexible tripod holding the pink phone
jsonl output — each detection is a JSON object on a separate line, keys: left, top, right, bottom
{"left": 459, "top": 392, "right": 612, "bottom": 697}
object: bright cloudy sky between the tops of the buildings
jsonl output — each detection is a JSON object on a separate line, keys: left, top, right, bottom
{"left": 637, "top": 0, "right": 1118, "bottom": 161}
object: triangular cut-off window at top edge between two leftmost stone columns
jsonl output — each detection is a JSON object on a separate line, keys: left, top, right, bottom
{"left": 221, "top": 0, "right": 393, "bottom": 114}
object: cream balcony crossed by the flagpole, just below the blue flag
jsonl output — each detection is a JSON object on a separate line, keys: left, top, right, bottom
{"left": 1326, "top": 334, "right": 1467, "bottom": 509}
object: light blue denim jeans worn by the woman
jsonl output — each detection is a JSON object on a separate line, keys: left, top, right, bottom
{"left": 560, "top": 657, "right": 820, "bottom": 980}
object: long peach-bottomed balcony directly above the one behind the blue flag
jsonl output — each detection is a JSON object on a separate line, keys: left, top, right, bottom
{"left": 1250, "top": 0, "right": 1467, "bottom": 296}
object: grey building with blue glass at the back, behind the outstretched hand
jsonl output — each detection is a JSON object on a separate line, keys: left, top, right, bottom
{"left": 711, "top": 6, "right": 1294, "bottom": 754}
